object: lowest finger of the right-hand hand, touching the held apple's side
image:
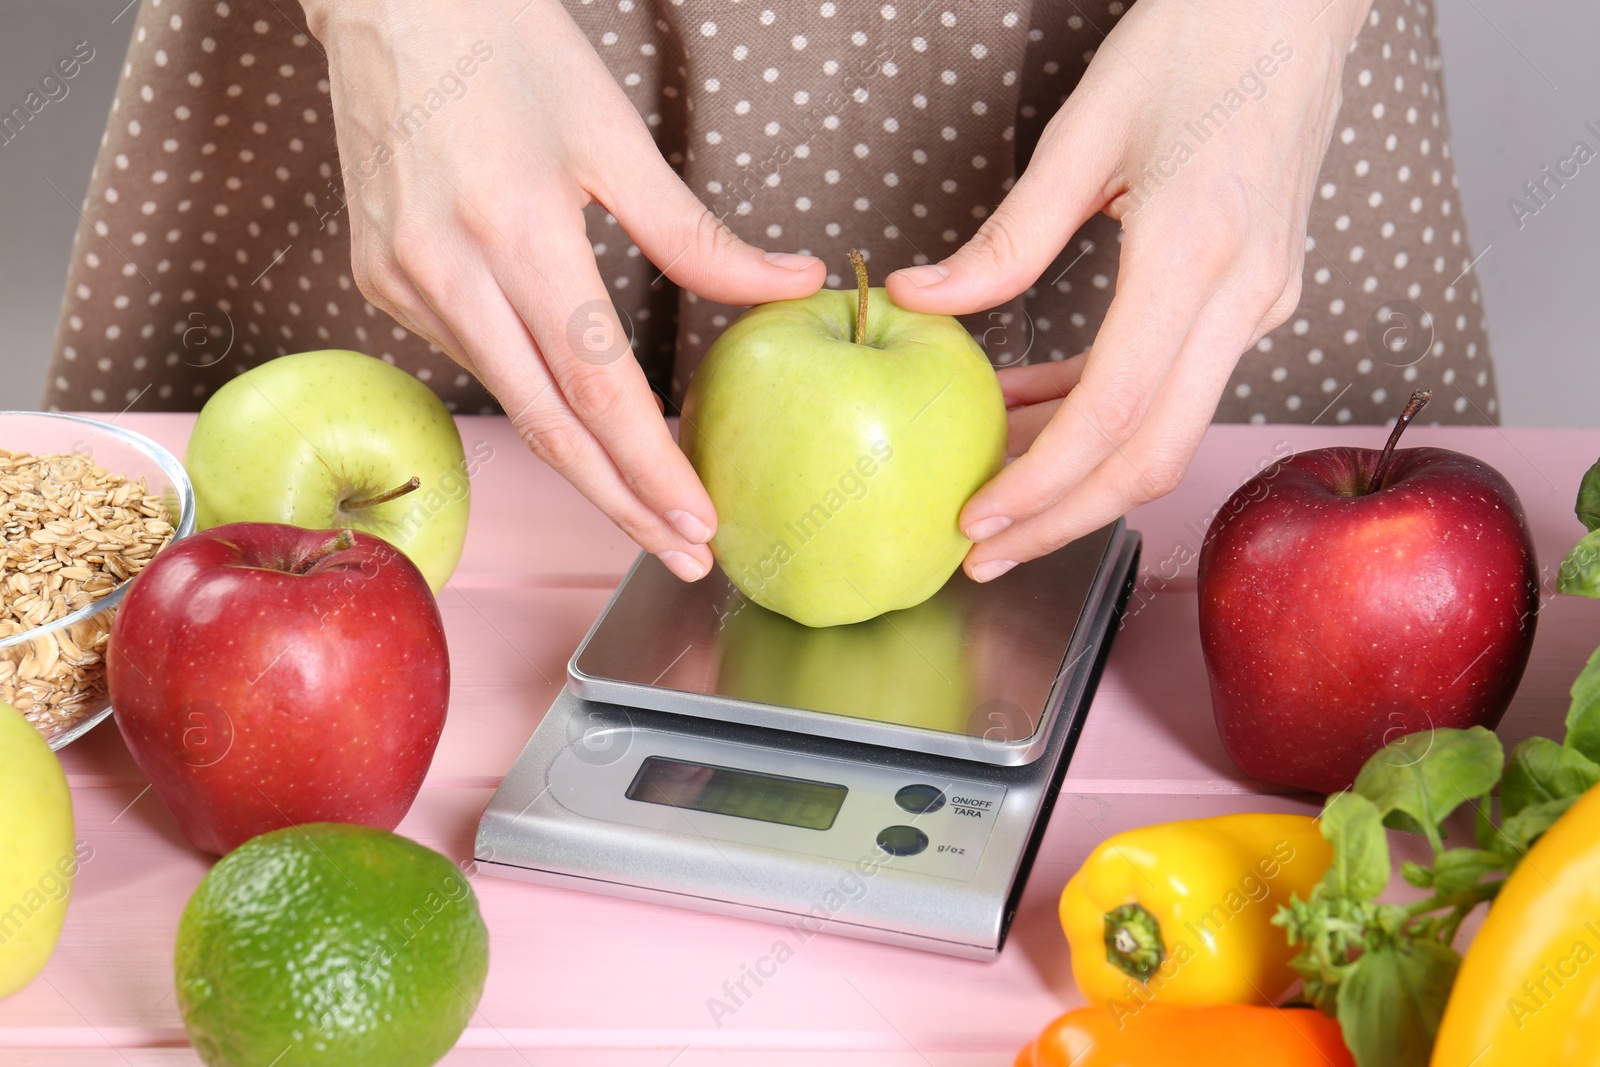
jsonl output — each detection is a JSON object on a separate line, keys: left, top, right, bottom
{"left": 963, "top": 287, "right": 1258, "bottom": 581}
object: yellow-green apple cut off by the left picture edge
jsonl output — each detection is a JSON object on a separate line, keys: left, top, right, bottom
{"left": 0, "top": 702, "right": 78, "bottom": 997}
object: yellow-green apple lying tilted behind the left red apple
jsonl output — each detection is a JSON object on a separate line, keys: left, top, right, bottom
{"left": 184, "top": 349, "right": 470, "bottom": 593}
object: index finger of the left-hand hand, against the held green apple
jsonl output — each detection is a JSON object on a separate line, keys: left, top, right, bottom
{"left": 476, "top": 213, "right": 717, "bottom": 558}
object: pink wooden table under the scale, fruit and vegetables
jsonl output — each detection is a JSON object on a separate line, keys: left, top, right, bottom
{"left": 0, "top": 414, "right": 1600, "bottom": 1067}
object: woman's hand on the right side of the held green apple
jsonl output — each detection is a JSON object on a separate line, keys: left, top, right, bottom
{"left": 888, "top": 0, "right": 1371, "bottom": 581}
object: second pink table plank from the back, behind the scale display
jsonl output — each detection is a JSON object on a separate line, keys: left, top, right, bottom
{"left": 61, "top": 582, "right": 1600, "bottom": 793}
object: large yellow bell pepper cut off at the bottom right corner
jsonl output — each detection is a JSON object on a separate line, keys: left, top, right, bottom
{"left": 1432, "top": 785, "right": 1600, "bottom": 1067}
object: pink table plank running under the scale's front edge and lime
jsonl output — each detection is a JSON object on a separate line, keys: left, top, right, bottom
{"left": 0, "top": 787, "right": 1314, "bottom": 1059}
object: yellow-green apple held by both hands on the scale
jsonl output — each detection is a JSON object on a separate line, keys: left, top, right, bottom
{"left": 680, "top": 256, "right": 1006, "bottom": 625}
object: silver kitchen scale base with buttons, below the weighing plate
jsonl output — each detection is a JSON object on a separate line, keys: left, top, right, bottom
{"left": 475, "top": 533, "right": 1139, "bottom": 960}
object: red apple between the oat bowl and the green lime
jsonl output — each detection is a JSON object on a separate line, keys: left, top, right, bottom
{"left": 106, "top": 523, "right": 450, "bottom": 854}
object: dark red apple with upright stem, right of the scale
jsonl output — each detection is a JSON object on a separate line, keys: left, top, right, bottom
{"left": 1198, "top": 392, "right": 1539, "bottom": 793}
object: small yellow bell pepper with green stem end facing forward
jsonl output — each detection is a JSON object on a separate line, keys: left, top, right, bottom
{"left": 1061, "top": 813, "right": 1333, "bottom": 1017}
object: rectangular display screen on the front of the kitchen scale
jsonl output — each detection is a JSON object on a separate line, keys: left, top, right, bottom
{"left": 626, "top": 755, "right": 850, "bottom": 830}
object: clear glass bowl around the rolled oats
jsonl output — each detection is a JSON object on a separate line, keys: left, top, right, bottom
{"left": 0, "top": 411, "right": 195, "bottom": 749}
